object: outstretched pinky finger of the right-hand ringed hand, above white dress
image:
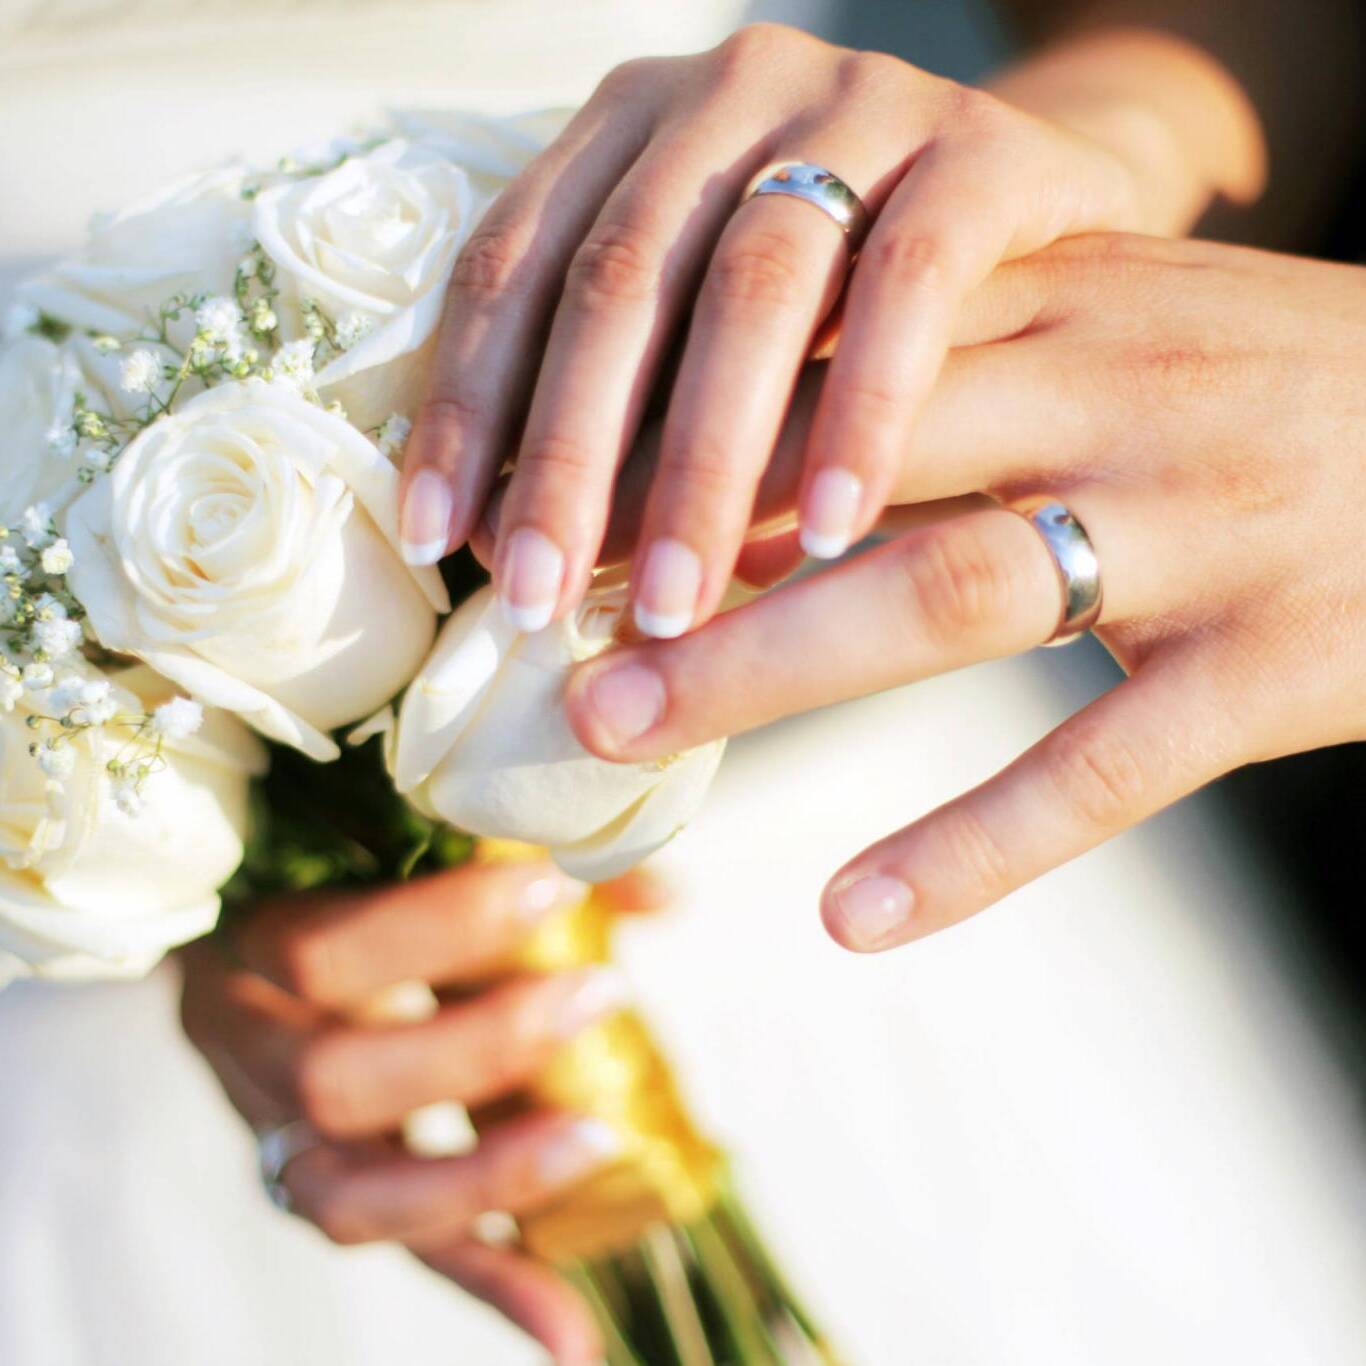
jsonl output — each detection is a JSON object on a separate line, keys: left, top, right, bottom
{"left": 821, "top": 652, "right": 1240, "bottom": 953}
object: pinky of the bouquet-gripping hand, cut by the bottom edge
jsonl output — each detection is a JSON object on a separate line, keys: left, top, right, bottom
{"left": 415, "top": 1240, "right": 602, "bottom": 1366}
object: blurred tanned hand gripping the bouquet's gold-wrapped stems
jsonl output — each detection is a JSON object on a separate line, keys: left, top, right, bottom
{"left": 182, "top": 863, "right": 658, "bottom": 1366}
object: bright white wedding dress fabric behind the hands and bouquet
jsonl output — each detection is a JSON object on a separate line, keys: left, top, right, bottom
{"left": 0, "top": 0, "right": 1366, "bottom": 1366}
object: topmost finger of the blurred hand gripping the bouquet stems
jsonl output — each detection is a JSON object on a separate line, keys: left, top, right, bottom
{"left": 238, "top": 862, "right": 587, "bottom": 1009}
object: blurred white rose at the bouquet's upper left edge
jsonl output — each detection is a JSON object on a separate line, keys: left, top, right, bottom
{"left": 18, "top": 167, "right": 251, "bottom": 342}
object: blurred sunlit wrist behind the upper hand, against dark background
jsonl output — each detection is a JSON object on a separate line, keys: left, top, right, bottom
{"left": 988, "top": 29, "right": 1266, "bottom": 235}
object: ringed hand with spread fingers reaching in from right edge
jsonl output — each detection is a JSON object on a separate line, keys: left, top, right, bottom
{"left": 557, "top": 236, "right": 1366, "bottom": 951}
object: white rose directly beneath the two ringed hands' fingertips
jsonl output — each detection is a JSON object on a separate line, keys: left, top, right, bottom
{"left": 389, "top": 587, "right": 725, "bottom": 881}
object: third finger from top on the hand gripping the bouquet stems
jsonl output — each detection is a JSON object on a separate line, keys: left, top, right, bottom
{"left": 281, "top": 1115, "right": 622, "bottom": 1244}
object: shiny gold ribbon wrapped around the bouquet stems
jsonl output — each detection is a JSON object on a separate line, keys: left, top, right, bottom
{"left": 473, "top": 840, "right": 725, "bottom": 1264}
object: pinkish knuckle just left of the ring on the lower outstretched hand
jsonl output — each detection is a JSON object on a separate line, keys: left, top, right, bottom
{"left": 900, "top": 526, "right": 1014, "bottom": 646}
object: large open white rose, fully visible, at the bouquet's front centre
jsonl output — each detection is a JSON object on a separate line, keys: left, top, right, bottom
{"left": 64, "top": 380, "right": 449, "bottom": 759}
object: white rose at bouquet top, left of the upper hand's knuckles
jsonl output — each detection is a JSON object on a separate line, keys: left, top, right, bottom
{"left": 254, "top": 139, "right": 486, "bottom": 428}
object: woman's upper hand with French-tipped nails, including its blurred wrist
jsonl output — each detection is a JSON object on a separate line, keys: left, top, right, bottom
{"left": 403, "top": 26, "right": 1259, "bottom": 637}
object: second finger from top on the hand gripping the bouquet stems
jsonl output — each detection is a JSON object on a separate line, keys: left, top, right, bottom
{"left": 292, "top": 967, "right": 628, "bottom": 1138}
